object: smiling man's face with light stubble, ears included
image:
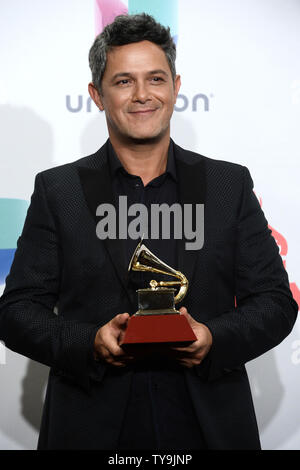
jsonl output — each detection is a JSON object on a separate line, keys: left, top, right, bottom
{"left": 89, "top": 41, "right": 180, "bottom": 141}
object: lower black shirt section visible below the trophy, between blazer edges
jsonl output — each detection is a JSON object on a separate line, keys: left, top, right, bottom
{"left": 117, "top": 360, "right": 206, "bottom": 451}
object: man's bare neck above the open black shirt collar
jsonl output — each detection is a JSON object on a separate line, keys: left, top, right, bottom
{"left": 110, "top": 135, "right": 170, "bottom": 186}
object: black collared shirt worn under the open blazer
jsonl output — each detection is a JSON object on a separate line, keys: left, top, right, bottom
{"left": 109, "top": 140, "right": 204, "bottom": 449}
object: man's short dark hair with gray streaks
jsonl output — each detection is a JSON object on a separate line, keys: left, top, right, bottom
{"left": 89, "top": 13, "right": 176, "bottom": 93}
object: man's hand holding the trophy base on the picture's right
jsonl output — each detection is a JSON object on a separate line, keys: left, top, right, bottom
{"left": 172, "top": 307, "right": 212, "bottom": 368}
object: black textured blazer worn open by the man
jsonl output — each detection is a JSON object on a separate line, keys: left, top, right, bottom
{"left": 0, "top": 143, "right": 298, "bottom": 449}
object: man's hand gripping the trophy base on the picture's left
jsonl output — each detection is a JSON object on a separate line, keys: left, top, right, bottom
{"left": 94, "top": 313, "right": 133, "bottom": 367}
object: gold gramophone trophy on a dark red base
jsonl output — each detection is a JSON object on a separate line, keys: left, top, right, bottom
{"left": 120, "top": 241, "right": 197, "bottom": 348}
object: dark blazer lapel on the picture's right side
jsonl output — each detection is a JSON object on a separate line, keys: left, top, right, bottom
{"left": 174, "top": 145, "right": 206, "bottom": 302}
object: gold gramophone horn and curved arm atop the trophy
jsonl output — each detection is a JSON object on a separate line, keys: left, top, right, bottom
{"left": 128, "top": 240, "right": 189, "bottom": 304}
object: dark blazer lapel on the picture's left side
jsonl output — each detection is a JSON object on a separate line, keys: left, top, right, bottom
{"left": 77, "top": 146, "right": 131, "bottom": 300}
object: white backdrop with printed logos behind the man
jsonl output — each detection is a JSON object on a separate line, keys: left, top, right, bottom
{"left": 0, "top": 0, "right": 300, "bottom": 449}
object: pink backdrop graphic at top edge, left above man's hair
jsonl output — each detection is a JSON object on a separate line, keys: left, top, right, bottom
{"left": 95, "top": 0, "right": 128, "bottom": 36}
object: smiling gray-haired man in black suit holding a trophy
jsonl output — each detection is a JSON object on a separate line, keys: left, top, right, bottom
{"left": 0, "top": 15, "right": 298, "bottom": 450}
